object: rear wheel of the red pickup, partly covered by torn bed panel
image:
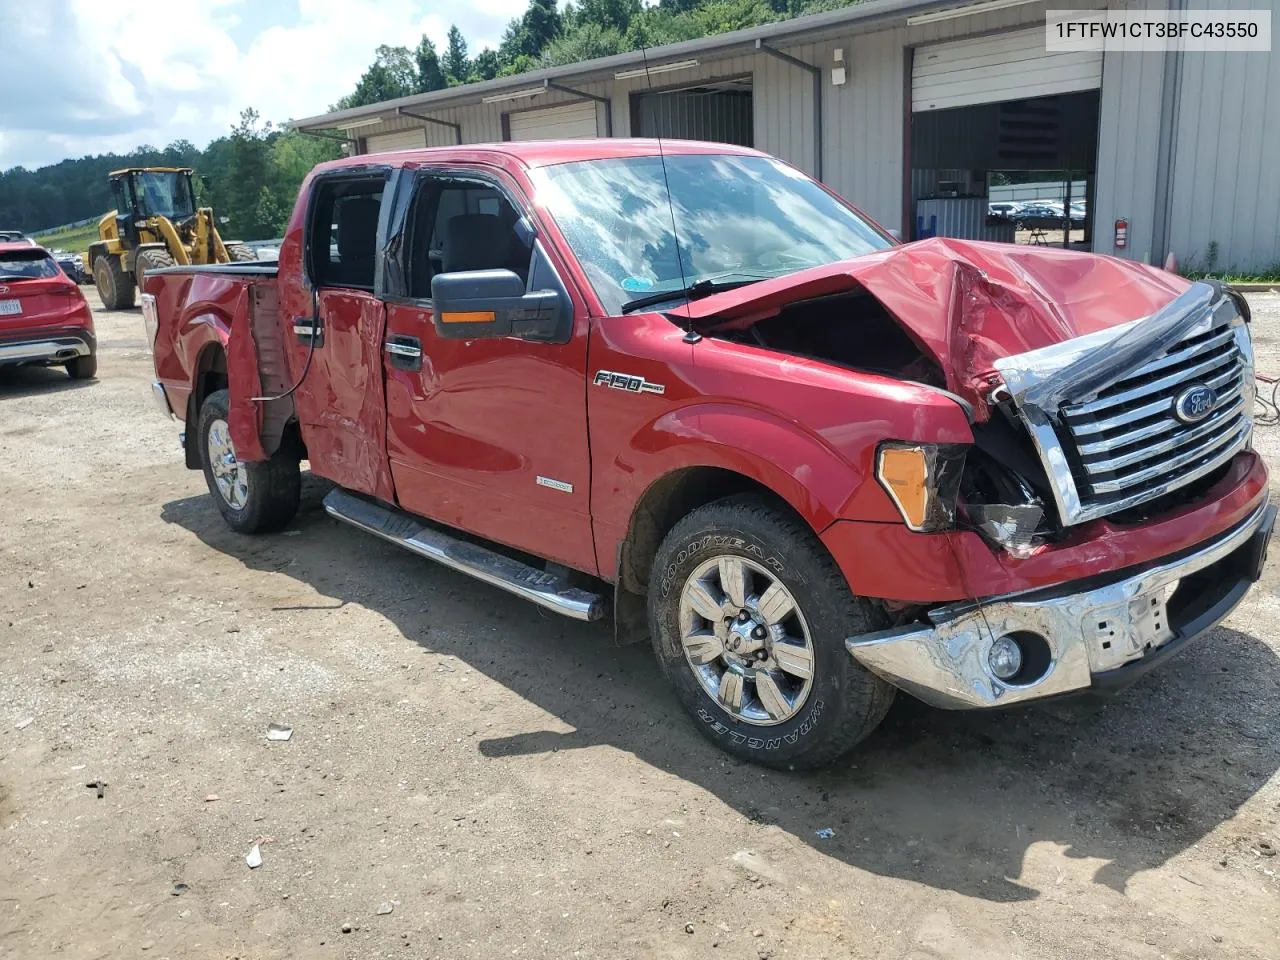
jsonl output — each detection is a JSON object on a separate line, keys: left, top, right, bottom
{"left": 196, "top": 390, "right": 302, "bottom": 534}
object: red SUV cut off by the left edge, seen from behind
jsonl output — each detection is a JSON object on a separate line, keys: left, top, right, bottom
{"left": 0, "top": 243, "right": 97, "bottom": 380}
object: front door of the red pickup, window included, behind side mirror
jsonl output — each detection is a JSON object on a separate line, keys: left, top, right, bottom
{"left": 384, "top": 172, "right": 596, "bottom": 573}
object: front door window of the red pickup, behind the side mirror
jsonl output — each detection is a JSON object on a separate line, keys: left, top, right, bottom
{"left": 408, "top": 178, "right": 532, "bottom": 300}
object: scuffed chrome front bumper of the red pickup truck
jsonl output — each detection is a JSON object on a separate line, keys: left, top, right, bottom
{"left": 845, "top": 503, "right": 1276, "bottom": 709}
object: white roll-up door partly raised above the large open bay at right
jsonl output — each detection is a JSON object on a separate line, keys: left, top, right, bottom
{"left": 911, "top": 29, "right": 1102, "bottom": 113}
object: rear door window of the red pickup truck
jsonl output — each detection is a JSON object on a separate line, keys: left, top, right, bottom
{"left": 307, "top": 177, "right": 385, "bottom": 291}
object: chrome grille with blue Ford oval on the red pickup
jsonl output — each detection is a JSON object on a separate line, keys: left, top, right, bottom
{"left": 993, "top": 283, "right": 1254, "bottom": 526}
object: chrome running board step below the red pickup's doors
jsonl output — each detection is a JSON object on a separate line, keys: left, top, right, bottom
{"left": 324, "top": 489, "right": 605, "bottom": 620}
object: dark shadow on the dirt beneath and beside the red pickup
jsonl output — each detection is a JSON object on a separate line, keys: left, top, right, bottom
{"left": 163, "top": 479, "right": 1280, "bottom": 901}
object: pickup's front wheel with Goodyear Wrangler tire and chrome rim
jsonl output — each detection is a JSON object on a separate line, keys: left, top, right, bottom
{"left": 649, "top": 495, "right": 895, "bottom": 769}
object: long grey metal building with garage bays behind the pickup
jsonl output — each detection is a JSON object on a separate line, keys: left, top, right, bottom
{"left": 293, "top": 0, "right": 1280, "bottom": 271}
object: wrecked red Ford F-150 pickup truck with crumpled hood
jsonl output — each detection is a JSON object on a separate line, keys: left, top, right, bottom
{"left": 143, "top": 140, "right": 1274, "bottom": 768}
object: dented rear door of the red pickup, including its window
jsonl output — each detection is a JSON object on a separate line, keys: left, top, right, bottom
{"left": 287, "top": 170, "right": 393, "bottom": 500}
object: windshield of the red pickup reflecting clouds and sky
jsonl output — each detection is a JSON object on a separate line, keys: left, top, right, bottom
{"left": 534, "top": 154, "right": 892, "bottom": 314}
